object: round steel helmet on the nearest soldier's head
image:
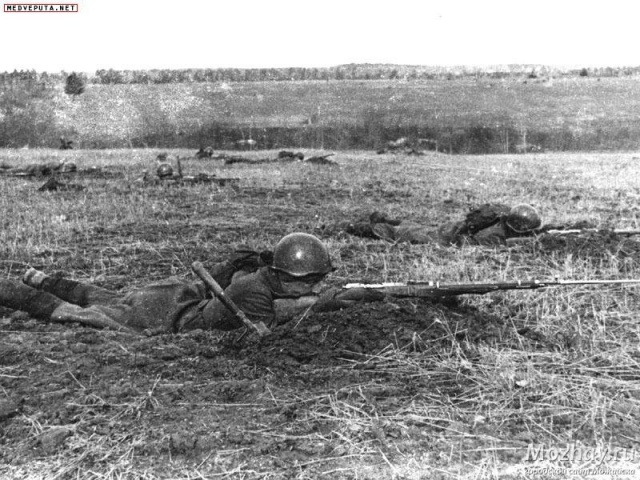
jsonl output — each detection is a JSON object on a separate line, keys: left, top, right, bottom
{"left": 271, "top": 233, "right": 333, "bottom": 277}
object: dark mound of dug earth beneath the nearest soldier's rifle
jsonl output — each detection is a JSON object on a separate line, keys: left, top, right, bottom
{"left": 224, "top": 299, "right": 501, "bottom": 368}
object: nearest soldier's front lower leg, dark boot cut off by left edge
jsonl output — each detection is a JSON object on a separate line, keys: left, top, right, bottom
{"left": 0, "top": 279, "right": 130, "bottom": 331}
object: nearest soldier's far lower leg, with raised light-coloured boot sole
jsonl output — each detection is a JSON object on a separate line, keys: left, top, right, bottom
{"left": 23, "top": 268, "right": 121, "bottom": 307}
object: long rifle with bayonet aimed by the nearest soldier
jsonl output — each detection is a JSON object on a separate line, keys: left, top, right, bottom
{"left": 342, "top": 279, "right": 640, "bottom": 298}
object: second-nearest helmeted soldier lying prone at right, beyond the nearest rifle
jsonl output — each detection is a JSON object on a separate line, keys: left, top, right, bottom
{"left": 344, "top": 204, "right": 542, "bottom": 246}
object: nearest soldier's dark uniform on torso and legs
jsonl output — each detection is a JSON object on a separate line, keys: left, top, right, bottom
{"left": 6, "top": 264, "right": 296, "bottom": 332}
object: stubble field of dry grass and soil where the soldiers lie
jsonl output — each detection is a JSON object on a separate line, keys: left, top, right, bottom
{"left": 0, "top": 149, "right": 640, "bottom": 480}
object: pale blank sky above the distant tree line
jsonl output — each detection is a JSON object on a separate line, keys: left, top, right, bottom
{"left": 0, "top": 0, "right": 640, "bottom": 73}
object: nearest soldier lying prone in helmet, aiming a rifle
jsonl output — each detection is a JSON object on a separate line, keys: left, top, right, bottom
{"left": 0, "top": 233, "right": 384, "bottom": 333}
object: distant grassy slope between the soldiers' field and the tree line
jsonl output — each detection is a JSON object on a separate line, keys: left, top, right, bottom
{"left": 6, "top": 77, "right": 640, "bottom": 150}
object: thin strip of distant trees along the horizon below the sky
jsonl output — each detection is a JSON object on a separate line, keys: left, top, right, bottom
{"left": 0, "top": 64, "right": 640, "bottom": 85}
